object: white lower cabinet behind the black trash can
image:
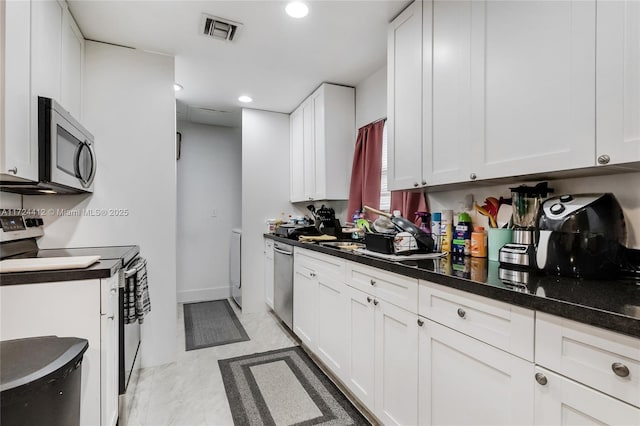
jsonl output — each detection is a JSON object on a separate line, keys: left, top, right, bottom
{"left": 0, "top": 275, "right": 118, "bottom": 426}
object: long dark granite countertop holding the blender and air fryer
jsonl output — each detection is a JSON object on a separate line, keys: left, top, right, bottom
{"left": 265, "top": 234, "right": 640, "bottom": 337}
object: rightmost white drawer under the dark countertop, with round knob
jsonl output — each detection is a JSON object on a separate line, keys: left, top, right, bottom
{"left": 536, "top": 313, "right": 640, "bottom": 407}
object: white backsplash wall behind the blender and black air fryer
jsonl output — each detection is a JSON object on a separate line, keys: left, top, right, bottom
{"left": 428, "top": 172, "right": 640, "bottom": 249}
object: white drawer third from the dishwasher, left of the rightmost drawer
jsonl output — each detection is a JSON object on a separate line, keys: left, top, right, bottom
{"left": 418, "top": 281, "right": 534, "bottom": 361}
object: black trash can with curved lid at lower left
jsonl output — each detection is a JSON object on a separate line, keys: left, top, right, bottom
{"left": 0, "top": 336, "right": 89, "bottom": 426}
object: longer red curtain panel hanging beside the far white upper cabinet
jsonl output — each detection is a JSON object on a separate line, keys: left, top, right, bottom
{"left": 347, "top": 120, "right": 385, "bottom": 222}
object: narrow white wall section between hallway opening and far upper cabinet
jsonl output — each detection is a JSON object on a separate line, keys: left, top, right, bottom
{"left": 242, "top": 109, "right": 292, "bottom": 313}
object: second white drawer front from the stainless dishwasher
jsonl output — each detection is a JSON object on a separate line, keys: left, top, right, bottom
{"left": 347, "top": 263, "right": 418, "bottom": 314}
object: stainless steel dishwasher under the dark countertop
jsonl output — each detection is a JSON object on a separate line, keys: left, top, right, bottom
{"left": 273, "top": 241, "right": 293, "bottom": 330}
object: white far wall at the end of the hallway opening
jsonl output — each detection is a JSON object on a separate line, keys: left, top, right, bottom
{"left": 177, "top": 121, "right": 242, "bottom": 302}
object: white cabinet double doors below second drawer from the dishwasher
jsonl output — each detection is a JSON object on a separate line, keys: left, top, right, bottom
{"left": 347, "top": 288, "right": 418, "bottom": 425}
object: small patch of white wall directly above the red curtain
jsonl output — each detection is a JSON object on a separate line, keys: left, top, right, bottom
{"left": 356, "top": 65, "right": 387, "bottom": 129}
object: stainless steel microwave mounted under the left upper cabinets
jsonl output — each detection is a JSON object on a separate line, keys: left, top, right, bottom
{"left": 38, "top": 96, "right": 96, "bottom": 193}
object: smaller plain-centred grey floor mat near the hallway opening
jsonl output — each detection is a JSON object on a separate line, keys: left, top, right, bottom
{"left": 184, "top": 299, "right": 249, "bottom": 351}
